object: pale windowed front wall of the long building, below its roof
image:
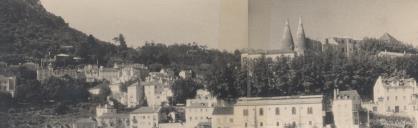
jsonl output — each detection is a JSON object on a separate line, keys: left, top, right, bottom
{"left": 234, "top": 103, "right": 324, "bottom": 128}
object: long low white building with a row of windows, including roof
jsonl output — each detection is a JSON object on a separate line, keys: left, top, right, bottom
{"left": 233, "top": 95, "right": 325, "bottom": 128}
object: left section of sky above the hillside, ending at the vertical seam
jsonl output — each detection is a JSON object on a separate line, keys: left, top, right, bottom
{"left": 41, "top": 0, "right": 219, "bottom": 48}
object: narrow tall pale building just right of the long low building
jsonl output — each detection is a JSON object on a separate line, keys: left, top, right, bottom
{"left": 332, "top": 89, "right": 361, "bottom": 128}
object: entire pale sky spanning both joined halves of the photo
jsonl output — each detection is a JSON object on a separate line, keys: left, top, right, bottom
{"left": 41, "top": 0, "right": 418, "bottom": 49}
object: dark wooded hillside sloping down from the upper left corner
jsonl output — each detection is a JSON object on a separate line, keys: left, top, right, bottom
{"left": 0, "top": 0, "right": 114, "bottom": 62}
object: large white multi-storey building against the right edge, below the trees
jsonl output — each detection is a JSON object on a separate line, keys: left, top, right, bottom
{"left": 366, "top": 76, "right": 418, "bottom": 115}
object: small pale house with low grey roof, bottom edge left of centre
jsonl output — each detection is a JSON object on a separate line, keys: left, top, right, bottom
{"left": 129, "top": 107, "right": 161, "bottom": 128}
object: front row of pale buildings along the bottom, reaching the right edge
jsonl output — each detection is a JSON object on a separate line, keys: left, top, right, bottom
{"left": 84, "top": 73, "right": 418, "bottom": 128}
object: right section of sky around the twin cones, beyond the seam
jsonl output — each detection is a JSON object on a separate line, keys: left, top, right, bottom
{"left": 249, "top": 0, "right": 418, "bottom": 49}
